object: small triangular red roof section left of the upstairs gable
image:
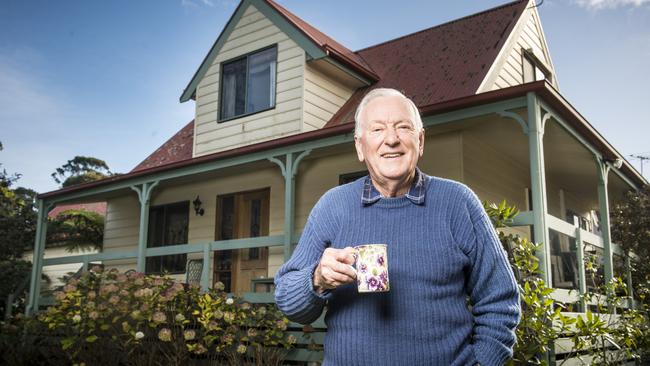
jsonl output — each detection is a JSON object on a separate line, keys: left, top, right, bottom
{"left": 131, "top": 120, "right": 194, "bottom": 172}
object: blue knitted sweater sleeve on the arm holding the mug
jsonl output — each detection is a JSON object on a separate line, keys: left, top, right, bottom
{"left": 275, "top": 190, "right": 337, "bottom": 324}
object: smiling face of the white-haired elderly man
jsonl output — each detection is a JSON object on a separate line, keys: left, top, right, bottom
{"left": 354, "top": 96, "right": 424, "bottom": 197}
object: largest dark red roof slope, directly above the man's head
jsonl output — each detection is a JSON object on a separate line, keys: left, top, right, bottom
{"left": 325, "top": 0, "right": 528, "bottom": 127}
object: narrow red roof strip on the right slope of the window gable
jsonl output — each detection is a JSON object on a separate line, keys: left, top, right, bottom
{"left": 266, "top": 0, "right": 378, "bottom": 80}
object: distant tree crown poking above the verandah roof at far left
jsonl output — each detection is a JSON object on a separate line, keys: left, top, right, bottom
{"left": 52, "top": 156, "right": 114, "bottom": 187}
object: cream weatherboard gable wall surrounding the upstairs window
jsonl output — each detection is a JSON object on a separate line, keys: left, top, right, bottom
{"left": 193, "top": 5, "right": 305, "bottom": 157}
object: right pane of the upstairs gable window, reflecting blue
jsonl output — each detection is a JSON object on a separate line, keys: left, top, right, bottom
{"left": 246, "top": 47, "right": 276, "bottom": 113}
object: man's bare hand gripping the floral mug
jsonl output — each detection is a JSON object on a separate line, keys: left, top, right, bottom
{"left": 314, "top": 247, "right": 357, "bottom": 293}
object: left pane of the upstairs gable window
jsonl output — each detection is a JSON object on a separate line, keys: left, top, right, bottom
{"left": 221, "top": 58, "right": 246, "bottom": 118}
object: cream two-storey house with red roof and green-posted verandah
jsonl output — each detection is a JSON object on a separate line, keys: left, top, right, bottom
{"left": 28, "top": 0, "right": 648, "bottom": 360}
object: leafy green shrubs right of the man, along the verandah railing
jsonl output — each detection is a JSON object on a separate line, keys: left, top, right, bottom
{"left": 483, "top": 202, "right": 650, "bottom": 365}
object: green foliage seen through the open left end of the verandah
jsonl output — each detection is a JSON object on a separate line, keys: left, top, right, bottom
{"left": 47, "top": 210, "right": 104, "bottom": 252}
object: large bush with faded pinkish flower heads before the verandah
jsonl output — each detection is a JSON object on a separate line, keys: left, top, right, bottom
{"left": 39, "top": 267, "right": 295, "bottom": 365}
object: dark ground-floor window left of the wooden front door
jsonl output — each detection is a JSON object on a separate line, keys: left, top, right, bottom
{"left": 145, "top": 201, "right": 190, "bottom": 273}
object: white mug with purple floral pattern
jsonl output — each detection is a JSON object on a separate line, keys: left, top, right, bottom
{"left": 354, "top": 244, "right": 390, "bottom": 292}
